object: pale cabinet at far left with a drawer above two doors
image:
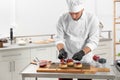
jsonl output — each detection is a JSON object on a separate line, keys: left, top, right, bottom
{"left": 0, "top": 49, "right": 30, "bottom": 80}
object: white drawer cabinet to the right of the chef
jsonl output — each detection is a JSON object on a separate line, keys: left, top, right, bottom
{"left": 93, "top": 40, "right": 113, "bottom": 65}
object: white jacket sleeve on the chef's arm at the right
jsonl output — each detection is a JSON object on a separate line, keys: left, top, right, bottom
{"left": 86, "top": 16, "right": 99, "bottom": 51}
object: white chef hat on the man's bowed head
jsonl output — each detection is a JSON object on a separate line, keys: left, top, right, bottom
{"left": 66, "top": 0, "right": 84, "bottom": 12}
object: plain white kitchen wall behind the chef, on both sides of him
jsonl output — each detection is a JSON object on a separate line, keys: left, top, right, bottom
{"left": 0, "top": 0, "right": 116, "bottom": 36}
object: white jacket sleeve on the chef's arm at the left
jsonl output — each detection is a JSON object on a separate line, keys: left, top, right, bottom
{"left": 55, "top": 17, "right": 65, "bottom": 45}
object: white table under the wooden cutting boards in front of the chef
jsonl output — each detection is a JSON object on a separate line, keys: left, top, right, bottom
{"left": 20, "top": 64, "right": 115, "bottom": 80}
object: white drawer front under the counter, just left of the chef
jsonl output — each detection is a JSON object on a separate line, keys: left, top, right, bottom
{"left": 31, "top": 47, "right": 52, "bottom": 60}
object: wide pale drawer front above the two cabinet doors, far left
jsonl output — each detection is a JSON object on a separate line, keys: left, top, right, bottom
{"left": 0, "top": 49, "right": 30, "bottom": 61}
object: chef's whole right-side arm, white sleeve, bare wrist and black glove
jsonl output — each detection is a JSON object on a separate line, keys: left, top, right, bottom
{"left": 72, "top": 17, "right": 99, "bottom": 61}
